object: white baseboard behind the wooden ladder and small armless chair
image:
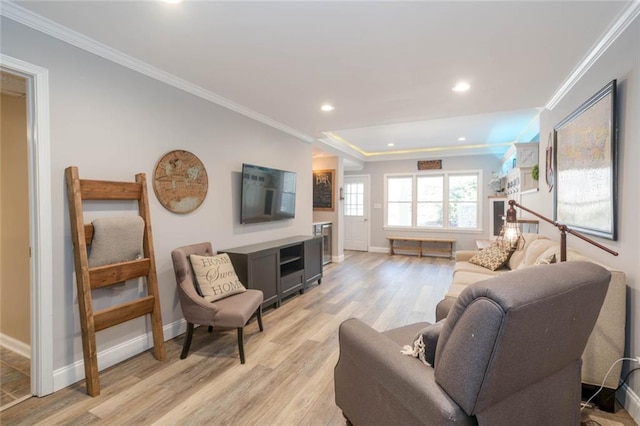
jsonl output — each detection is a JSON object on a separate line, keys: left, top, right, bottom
{"left": 53, "top": 319, "right": 187, "bottom": 392}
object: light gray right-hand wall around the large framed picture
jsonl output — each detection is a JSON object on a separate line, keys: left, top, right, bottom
{"left": 523, "top": 14, "right": 640, "bottom": 421}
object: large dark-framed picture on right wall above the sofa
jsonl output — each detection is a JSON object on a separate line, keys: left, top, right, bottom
{"left": 553, "top": 80, "right": 618, "bottom": 241}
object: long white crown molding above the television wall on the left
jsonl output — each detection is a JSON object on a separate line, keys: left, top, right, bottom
{"left": 0, "top": 1, "right": 315, "bottom": 143}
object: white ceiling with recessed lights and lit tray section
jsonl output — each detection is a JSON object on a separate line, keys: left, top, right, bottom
{"left": 3, "top": 0, "right": 637, "bottom": 168}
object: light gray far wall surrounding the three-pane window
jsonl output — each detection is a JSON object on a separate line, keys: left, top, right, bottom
{"left": 345, "top": 155, "right": 500, "bottom": 250}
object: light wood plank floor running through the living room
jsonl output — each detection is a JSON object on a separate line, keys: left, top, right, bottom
{"left": 0, "top": 252, "right": 633, "bottom": 425}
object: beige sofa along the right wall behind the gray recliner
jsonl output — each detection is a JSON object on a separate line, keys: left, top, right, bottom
{"left": 436, "top": 234, "right": 626, "bottom": 398}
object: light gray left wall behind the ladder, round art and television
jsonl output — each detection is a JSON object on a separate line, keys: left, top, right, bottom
{"left": 1, "top": 18, "right": 312, "bottom": 383}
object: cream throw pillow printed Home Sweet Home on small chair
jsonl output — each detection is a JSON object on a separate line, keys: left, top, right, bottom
{"left": 189, "top": 253, "right": 247, "bottom": 302}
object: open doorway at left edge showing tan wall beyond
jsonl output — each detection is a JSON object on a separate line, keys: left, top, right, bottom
{"left": 0, "top": 71, "right": 31, "bottom": 410}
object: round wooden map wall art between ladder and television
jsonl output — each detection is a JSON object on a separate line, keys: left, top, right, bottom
{"left": 153, "top": 150, "right": 209, "bottom": 213}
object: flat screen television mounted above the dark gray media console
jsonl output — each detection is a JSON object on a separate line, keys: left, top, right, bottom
{"left": 240, "top": 164, "right": 296, "bottom": 223}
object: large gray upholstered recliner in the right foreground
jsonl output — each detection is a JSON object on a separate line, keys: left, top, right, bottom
{"left": 334, "top": 262, "right": 610, "bottom": 425}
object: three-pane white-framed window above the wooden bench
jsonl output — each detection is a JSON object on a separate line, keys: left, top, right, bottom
{"left": 385, "top": 171, "right": 482, "bottom": 230}
